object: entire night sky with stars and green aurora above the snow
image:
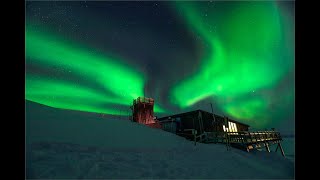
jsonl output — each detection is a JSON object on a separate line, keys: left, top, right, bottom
{"left": 25, "top": 1, "right": 295, "bottom": 133}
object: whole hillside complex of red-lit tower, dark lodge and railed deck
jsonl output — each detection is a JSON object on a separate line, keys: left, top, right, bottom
{"left": 131, "top": 100, "right": 285, "bottom": 156}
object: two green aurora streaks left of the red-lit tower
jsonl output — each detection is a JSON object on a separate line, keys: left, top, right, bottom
{"left": 26, "top": 27, "right": 163, "bottom": 114}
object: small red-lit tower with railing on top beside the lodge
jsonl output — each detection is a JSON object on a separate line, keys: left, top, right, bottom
{"left": 132, "top": 97, "right": 155, "bottom": 124}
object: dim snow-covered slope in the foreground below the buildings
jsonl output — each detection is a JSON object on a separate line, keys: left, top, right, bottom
{"left": 26, "top": 102, "right": 294, "bottom": 179}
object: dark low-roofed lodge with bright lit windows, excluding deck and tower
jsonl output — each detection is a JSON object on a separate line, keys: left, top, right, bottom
{"left": 158, "top": 110, "right": 249, "bottom": 134}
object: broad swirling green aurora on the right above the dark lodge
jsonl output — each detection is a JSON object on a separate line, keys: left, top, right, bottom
{"left": 172, "top": 2, "right": 294, "bottom": 126}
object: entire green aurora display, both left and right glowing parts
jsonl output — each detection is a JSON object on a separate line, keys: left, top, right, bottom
{"left": 25, "top": 1, "right": 294, "bottom": 128}
